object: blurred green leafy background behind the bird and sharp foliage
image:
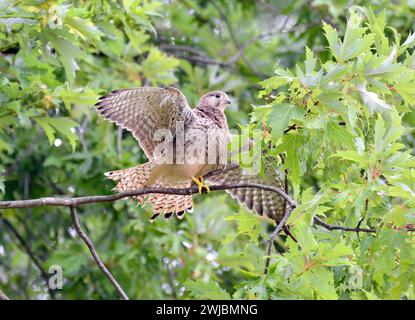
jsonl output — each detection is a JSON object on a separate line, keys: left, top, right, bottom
{"left": 0, "top": 0, "right": 415, "bottom": 299}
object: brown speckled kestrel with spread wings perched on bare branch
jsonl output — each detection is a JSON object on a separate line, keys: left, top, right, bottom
{"left": 96, "top": 87, "right": 285, "bottom": 221}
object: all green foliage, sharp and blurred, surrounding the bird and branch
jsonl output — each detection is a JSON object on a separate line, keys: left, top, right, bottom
{"left": 0, "top": 0, "right": 415, "bottom": 299}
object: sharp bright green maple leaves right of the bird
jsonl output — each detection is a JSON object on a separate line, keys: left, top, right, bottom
{"left": 254, "top": 8, "right": 415, "bottom": 299}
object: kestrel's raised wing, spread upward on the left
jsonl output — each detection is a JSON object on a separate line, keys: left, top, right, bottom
{"left": 96, "top": 87, "right": 195, "bottom": 160}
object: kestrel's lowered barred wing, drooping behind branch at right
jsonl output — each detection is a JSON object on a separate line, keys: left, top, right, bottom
{"left": 207, "top": 164, "right": 285, "bottom": 222}
